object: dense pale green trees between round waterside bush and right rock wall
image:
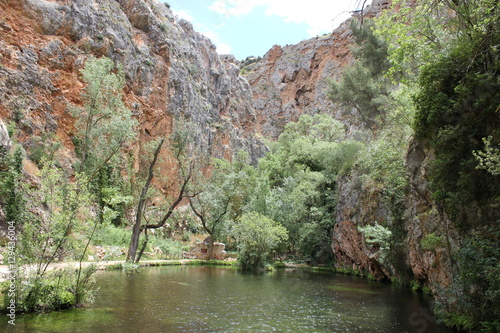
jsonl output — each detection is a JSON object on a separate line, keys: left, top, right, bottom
{"left": 253, "top": 114, "right": 363, "bottom": 263}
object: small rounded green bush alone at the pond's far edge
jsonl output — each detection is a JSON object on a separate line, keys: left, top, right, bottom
{"left": 233, "top": 212, "right": 288, "bottom": 271}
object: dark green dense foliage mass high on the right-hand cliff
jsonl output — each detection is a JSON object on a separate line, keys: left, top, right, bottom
{"left": 415, "top": 33, "right": 500, "bottom": 231}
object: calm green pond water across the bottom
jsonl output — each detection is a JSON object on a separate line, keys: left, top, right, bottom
{"left": 0, "top": 267, "right": 451, "bottom": 333}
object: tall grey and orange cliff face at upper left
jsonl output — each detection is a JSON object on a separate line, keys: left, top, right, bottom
{"left": 0, "top": 0, "right": 265, "bottom": 166}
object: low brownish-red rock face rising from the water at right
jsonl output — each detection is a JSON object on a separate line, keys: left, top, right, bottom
{"left": 332, "top": 140, "right": 461, "bottom": 286}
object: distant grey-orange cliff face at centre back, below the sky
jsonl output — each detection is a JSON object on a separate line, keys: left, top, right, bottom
{"left": 245, "top": 0, "right": 391, "bottom": 138}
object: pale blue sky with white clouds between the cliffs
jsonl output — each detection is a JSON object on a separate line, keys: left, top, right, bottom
{"left": 166, "top": 0, "right": 371, "bottom": 60}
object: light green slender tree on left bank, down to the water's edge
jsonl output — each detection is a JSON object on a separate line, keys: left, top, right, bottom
{"left": 4, "top": 161, "right": 95, "bottom": 312}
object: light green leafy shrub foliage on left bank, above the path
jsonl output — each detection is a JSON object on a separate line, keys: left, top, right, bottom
{"left": 19, "top": 162, "right": 92, "bottom": 262}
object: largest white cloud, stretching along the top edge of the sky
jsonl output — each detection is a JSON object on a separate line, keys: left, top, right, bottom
{"left": 209, "top": 0, "right": 370, "bottom": 36}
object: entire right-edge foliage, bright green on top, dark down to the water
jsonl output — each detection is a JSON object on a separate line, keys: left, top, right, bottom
{"left": 376, "top": 0, "right": 500, "bottom": 331}
